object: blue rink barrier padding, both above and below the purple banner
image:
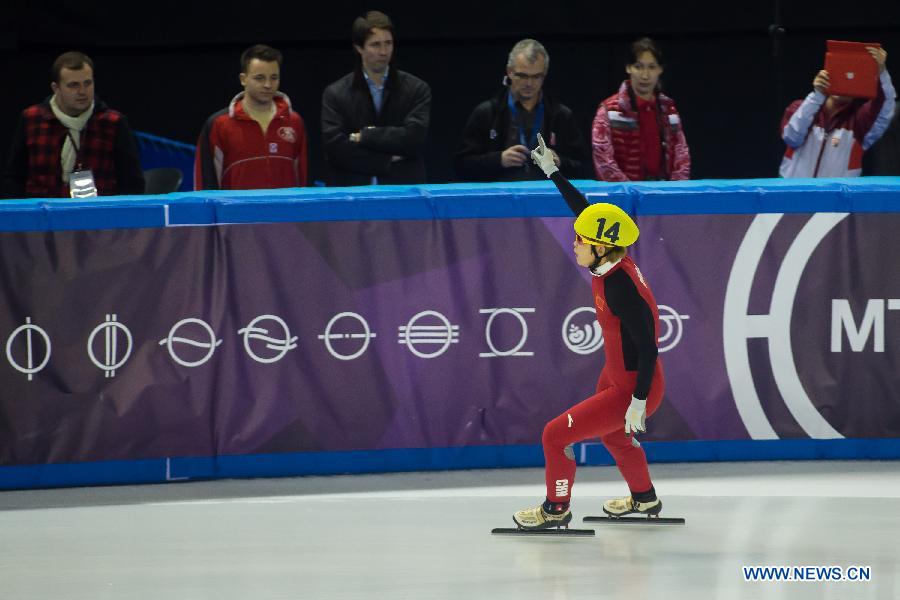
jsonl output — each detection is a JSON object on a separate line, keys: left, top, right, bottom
{"left": 0, "top": 177, "right": 900, "bottom": 489}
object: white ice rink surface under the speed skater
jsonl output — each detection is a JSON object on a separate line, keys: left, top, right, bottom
{"left": 0, "top": 461, "right": 900, "bottom": 600}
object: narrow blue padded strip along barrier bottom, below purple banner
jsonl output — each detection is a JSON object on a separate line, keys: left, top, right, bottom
{"left": 0, "top": 439, "right": 900, "bottom": 490}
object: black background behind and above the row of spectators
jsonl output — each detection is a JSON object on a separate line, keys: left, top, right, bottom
{"left": 0, "top": 0, "right": 900, "bottom": 182}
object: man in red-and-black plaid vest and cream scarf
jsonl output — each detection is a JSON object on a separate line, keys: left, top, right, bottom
{"left": 2, "top": 52, "right": 144, "bottom": 198}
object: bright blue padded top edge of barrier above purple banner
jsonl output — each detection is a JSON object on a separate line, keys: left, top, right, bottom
{"left": 0, "top": 177, "right": 900, "bottom": 231}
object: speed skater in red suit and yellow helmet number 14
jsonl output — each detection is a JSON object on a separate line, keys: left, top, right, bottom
{"left": 513, "top": 137, "right": 665, "bottom": 529}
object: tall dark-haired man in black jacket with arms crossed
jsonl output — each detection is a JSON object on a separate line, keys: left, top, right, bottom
{"left": 322, "top": 11, "right": 431, "bottom": 186}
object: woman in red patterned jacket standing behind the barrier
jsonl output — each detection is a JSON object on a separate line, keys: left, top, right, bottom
{"left": 591, "top": 37, "right": 691, "bottom": 181}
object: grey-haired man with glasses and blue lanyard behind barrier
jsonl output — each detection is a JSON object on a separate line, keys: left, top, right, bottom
{"left": 454, "top": 39, "right": 584, "bottom": 181}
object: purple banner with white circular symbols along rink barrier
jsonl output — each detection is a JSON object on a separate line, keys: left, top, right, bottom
{"left": 0, "top": 213, "right": 900, "bottom": 465}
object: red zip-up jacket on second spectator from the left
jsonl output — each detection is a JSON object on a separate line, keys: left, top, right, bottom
{"left": 194, "top": 92, "right": 307, "bottom": 190}
